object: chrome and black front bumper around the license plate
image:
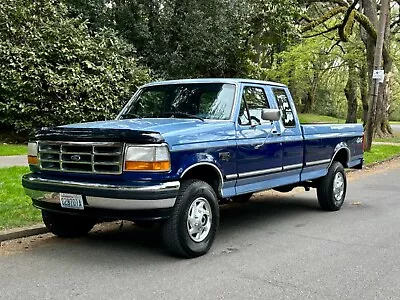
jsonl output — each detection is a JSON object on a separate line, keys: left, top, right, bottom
{"left": 22, "top": 174, "right": 180, "bottom": 213}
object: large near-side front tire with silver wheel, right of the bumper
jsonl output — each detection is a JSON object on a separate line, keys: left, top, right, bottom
{"left": 162, "top": 180, "right": 219, "bottom": 258}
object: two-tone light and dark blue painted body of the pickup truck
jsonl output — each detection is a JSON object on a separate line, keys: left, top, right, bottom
{"left": 31, "top": 79, "right": 363, "bottom": 197}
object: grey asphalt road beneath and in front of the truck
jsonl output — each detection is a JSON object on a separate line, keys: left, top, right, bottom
{"left": 0, "top": 161, "right": 400, "bottom": 299}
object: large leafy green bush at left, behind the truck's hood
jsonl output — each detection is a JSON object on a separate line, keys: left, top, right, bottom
{"left": 0, "top": 0, "right": 150, "bottom": 132}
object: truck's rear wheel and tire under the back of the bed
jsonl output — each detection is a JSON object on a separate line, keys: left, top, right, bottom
{"left": 317, "top": 161, "right": 347, "bottom": 211}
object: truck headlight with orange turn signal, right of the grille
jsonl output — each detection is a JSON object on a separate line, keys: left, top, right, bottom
{"left": 125, "top": 145, "right": 171, "bottom": 172}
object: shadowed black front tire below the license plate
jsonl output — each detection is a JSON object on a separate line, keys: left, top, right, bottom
{"left": 42, "top": 210, "right": 96, "bottom": 238}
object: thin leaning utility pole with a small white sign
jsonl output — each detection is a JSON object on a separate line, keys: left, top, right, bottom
{"left": 364, "top": 0, "right": 389, "bottom": 151}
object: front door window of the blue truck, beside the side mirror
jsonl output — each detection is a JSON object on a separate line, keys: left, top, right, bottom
{"left": 239, "top": 86, "right": 269, "bottom": 125}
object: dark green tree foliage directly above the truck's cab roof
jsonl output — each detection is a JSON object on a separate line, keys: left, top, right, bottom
{"left": 114, "top": 0, "right": 246, "bottom": 78}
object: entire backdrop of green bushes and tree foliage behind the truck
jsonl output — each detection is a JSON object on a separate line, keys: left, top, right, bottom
{"left": 0, "top": 0, "right": 400, "bottom": 138}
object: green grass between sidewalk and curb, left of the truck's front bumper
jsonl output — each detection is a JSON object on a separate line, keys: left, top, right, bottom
{"left": 0, "top": 167, "right": 41, "bottom": 230}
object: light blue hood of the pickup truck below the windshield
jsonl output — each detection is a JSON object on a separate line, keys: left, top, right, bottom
{"left": 58, "top": 118, "right": 234, "bottom": 146}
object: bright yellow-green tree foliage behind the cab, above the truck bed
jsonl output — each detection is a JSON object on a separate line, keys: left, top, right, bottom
{"left": 261, "top": 37, "right": 346, "bottom": 117}
